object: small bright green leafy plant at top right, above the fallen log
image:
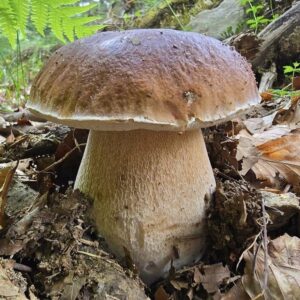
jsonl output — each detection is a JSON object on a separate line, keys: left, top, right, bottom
{"left": 241, "top": 0, "right": 278, "bottom": 33}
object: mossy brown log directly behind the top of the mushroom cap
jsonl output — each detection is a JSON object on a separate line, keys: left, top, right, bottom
{"left": 134, "top": 0, "right": 221, "bottom": 29}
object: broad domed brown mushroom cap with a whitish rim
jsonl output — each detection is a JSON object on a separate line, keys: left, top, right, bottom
{"left": 27, "top": 29, "right": 260, "bottom": 131}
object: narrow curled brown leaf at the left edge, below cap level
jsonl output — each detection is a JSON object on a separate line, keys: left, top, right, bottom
{"left": 0, "top": 164, "right": 17, "bottom": 229}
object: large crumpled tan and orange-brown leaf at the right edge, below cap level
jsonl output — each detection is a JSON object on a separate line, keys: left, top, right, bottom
{"left": 237, "top": 126, "right": 300, "bottom": 191}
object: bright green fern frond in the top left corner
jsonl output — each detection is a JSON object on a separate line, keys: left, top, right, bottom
{"left": 0, "top": 0, "right": 104, "bottom": 48}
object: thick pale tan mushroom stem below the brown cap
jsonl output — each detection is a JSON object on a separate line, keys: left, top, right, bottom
{"left": 75, "top": 130, "right": 215, "bottom": 283}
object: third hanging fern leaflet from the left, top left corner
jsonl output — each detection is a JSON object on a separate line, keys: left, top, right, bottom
{"left": 31, "top": 0, "right": 49, "bottom": 36}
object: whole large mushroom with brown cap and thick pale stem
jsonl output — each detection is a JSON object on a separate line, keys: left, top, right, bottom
{"left": 27, "top": 29, "right": 260, "bottom": 283}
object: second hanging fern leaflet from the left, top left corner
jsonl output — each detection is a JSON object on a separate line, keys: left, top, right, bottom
{"left": 9, "top": 0, "right": 29, "bottom": 36}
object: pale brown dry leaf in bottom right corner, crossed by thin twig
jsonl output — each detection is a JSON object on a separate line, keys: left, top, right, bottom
{"left": 242, "top": 234, "right": 300, "bottom": 300}
